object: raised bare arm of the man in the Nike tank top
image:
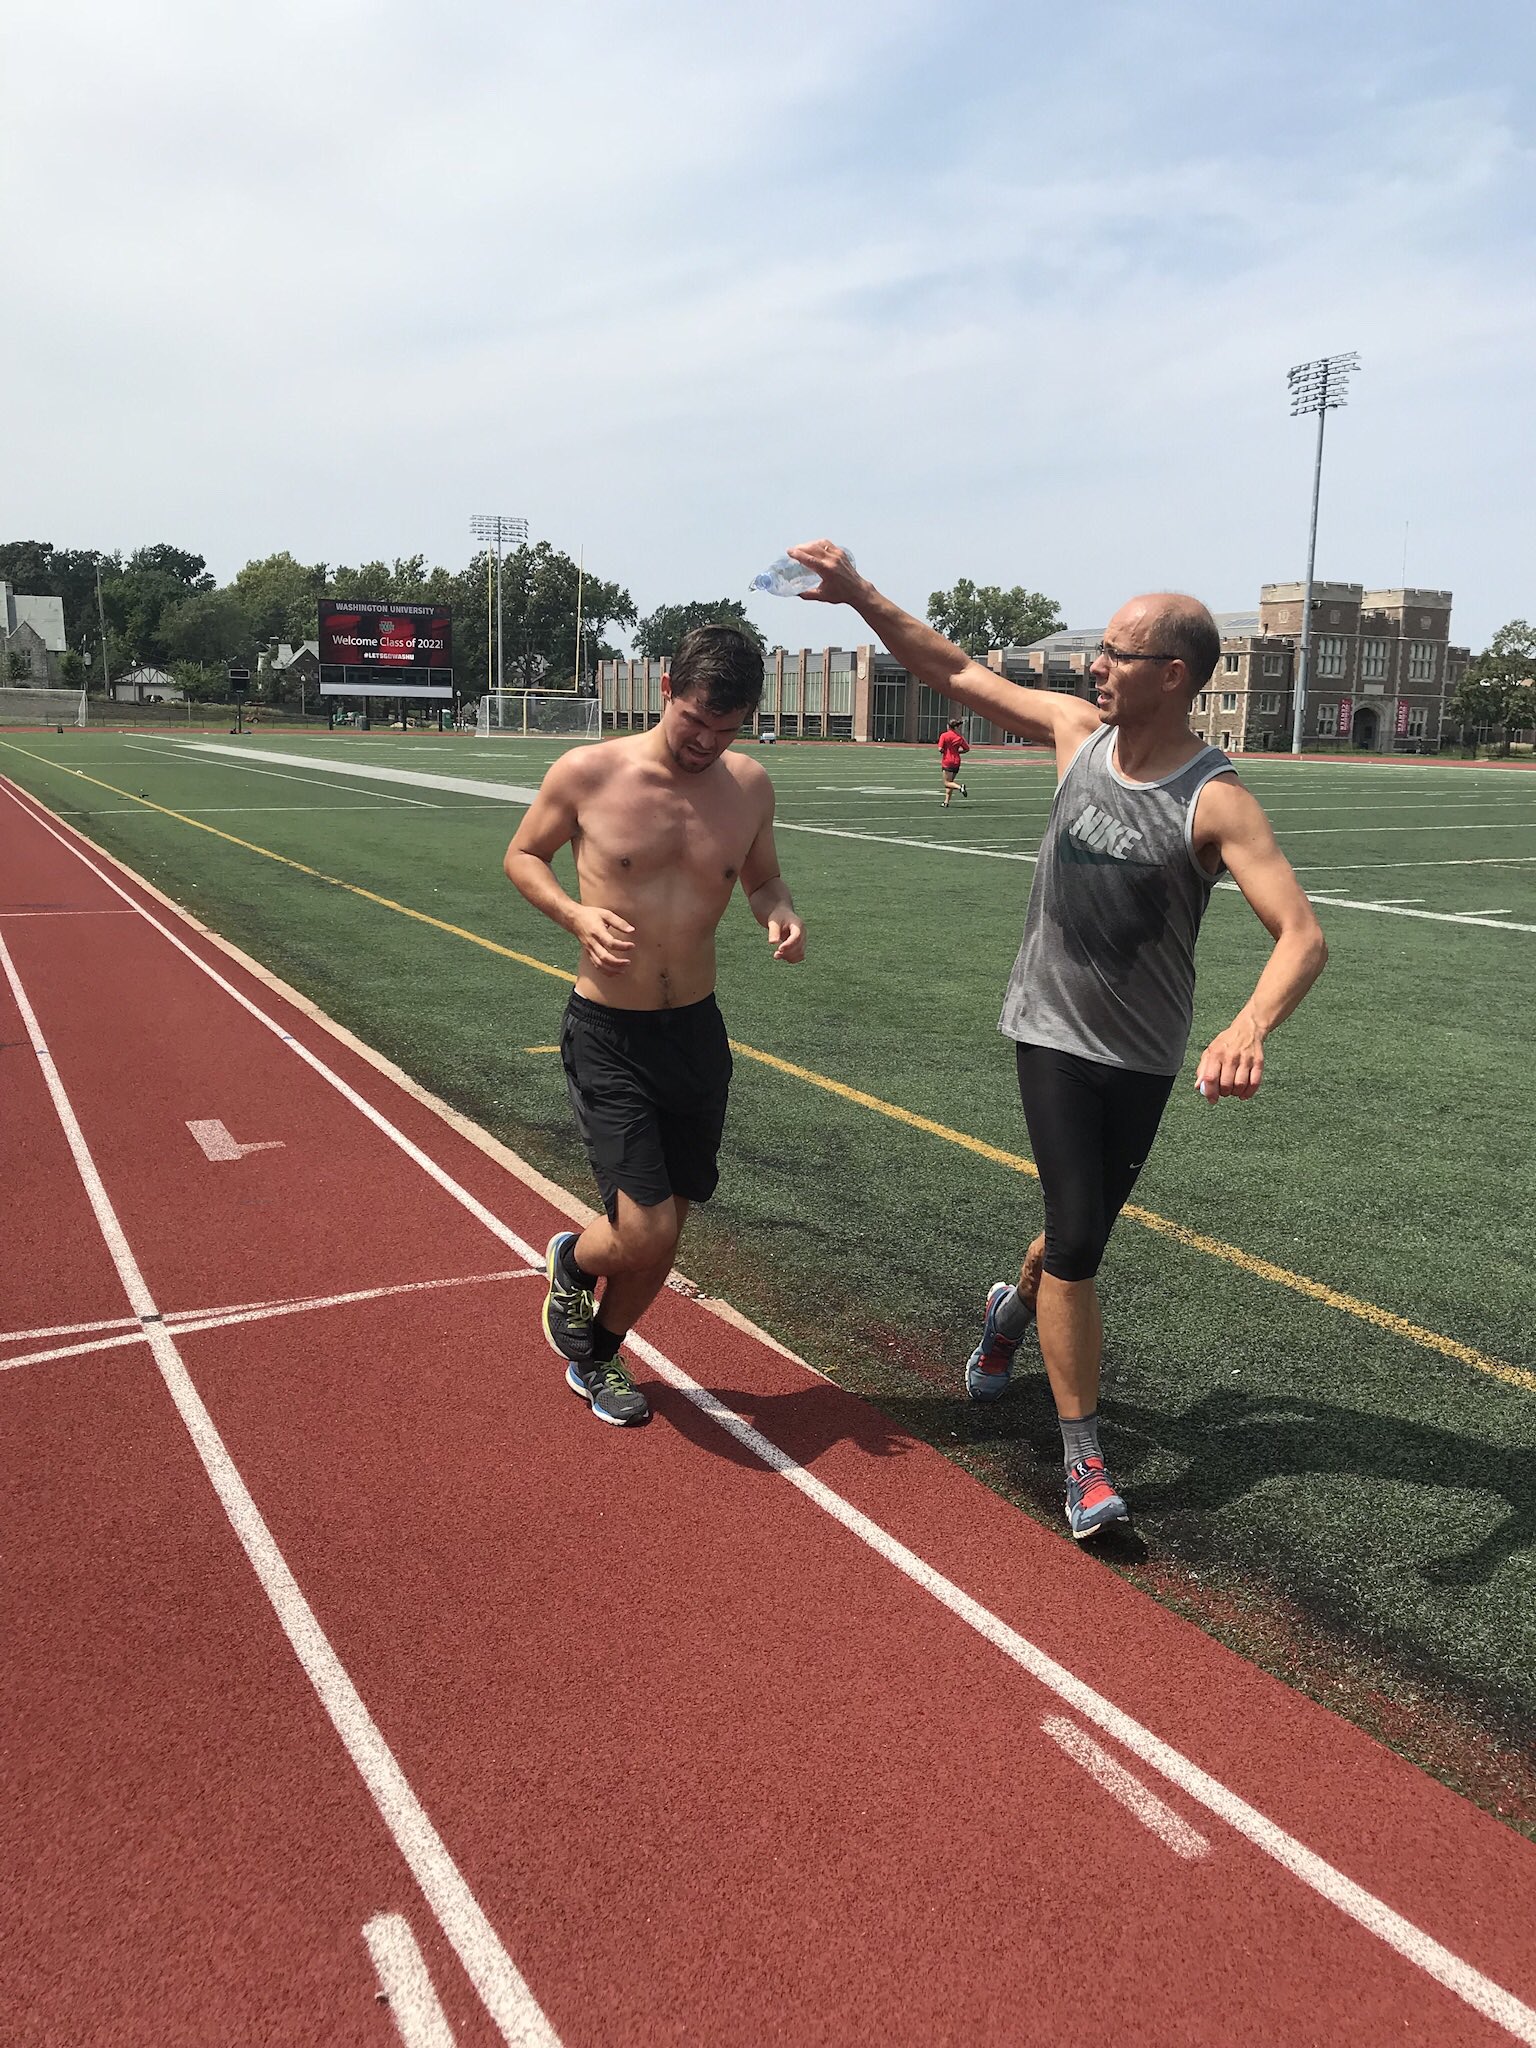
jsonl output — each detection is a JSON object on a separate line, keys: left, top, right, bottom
{"left": 791, "top": 541, "right": 1100, "bottom": 774}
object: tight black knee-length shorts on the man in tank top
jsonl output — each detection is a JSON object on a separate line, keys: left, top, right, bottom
{"left": 1016, "top": 1044, "right": 1176, "bottom": 1280}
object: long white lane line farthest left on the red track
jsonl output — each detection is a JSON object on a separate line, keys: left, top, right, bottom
{"left": 0, "top": 938, "right": 559, "bottom": 2048}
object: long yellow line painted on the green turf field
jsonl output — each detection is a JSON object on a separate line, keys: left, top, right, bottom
{"left": 0, "top": 741, "right": 1536, "bottom": 1393}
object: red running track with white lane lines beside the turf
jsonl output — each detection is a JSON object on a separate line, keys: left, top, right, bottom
{"left": 0, "top": 782, "right": 1536, "bottom": 2048}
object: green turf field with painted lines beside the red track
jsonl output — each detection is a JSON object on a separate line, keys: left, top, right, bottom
{"left": 0, "top": 729, "right": 1536, "bottom": 1833}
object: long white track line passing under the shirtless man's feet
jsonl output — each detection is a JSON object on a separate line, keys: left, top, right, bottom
{"left": 12, "top": 774, "right": 1536, "bottom": 2048}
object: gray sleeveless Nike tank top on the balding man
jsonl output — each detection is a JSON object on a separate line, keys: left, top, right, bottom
{"left": 997, "top": 725, "right": 1233, "bottom": 1073}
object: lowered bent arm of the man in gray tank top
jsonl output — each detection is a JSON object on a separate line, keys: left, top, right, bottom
{"left": 1194, "top": 776, "right": 1327, "bottom": 1102}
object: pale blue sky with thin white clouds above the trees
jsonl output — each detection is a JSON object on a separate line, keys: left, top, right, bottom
{"left": 0, "top": 0, "right": 1536, "bottom": 649}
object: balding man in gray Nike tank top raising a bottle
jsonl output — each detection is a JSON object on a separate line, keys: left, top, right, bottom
{"left": 791, "top": 541, "right": 1327, "bottom": 1540}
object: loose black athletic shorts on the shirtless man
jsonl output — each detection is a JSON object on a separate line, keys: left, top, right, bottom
{"left": 559, "top": 995, "right": 731, "bottom": 1223}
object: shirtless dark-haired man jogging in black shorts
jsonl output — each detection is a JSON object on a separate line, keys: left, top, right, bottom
{"left": 506, "top": 627, "right": 805, "bottom": 1423}
